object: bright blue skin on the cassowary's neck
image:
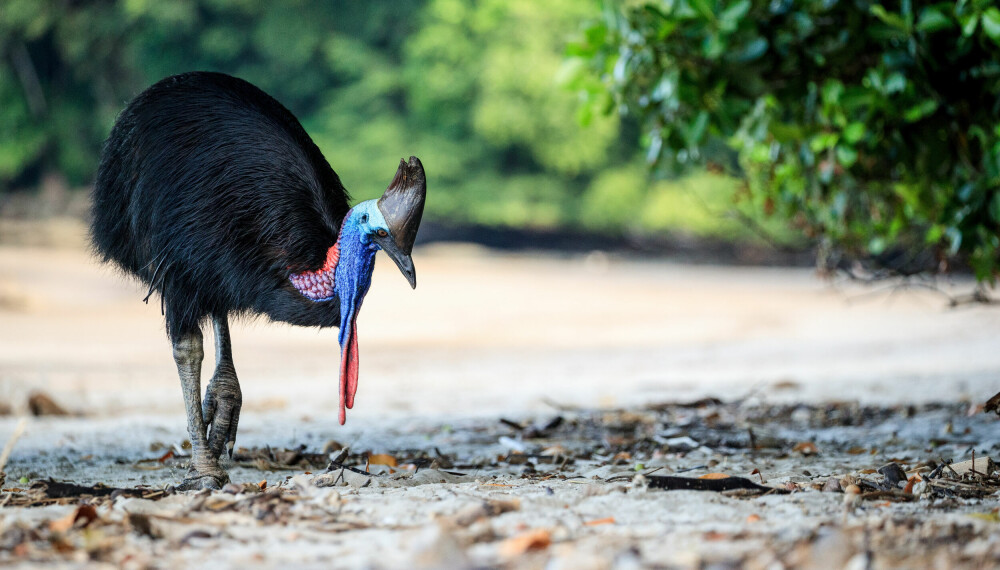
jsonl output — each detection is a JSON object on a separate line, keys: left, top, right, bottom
{"left": 334, "top": 208, "right": 381, "bottom": 346}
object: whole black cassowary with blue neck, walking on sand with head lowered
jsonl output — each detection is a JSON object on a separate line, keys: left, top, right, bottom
{"left": 91, "top": 72, "right": 426, "bottom": 489}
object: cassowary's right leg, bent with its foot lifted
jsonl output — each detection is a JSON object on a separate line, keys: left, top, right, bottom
{"left": 203, "top": 315, "right": 243, "bottom": 457}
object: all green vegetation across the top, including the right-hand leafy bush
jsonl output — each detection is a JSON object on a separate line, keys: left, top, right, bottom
{"left": 0, "top": 0, "right": 1000, "bottom": 282}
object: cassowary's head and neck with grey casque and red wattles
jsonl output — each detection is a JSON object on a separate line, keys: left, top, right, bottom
{"left": 290, "top": 156, "right": 427, "bottom": 424}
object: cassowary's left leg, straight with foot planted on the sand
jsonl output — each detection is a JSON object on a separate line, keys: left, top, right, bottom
{"left": 174, "top": 329, "right": 229, "bottom": 490}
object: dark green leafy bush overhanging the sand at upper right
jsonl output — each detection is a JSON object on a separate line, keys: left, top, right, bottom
{"left": 570, "top": 0, "right": 1000, "bottom": 282}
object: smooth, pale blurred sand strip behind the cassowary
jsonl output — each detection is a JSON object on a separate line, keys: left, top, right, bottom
{"left": 0, "top": 239, "right": 1000, "bottom": 421}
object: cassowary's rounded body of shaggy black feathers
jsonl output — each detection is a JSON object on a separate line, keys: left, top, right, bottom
{"left": 91, "top": 72, "right": 349, "bottom": 338}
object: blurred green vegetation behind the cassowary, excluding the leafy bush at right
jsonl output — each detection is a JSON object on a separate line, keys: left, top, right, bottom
{"left": 0, "top": 0, "right": 792, "bottom": 248}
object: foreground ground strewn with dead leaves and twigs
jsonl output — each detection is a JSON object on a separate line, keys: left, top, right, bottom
{"left": 0, "top": 399, "right": 1000, "bottom": 567}
